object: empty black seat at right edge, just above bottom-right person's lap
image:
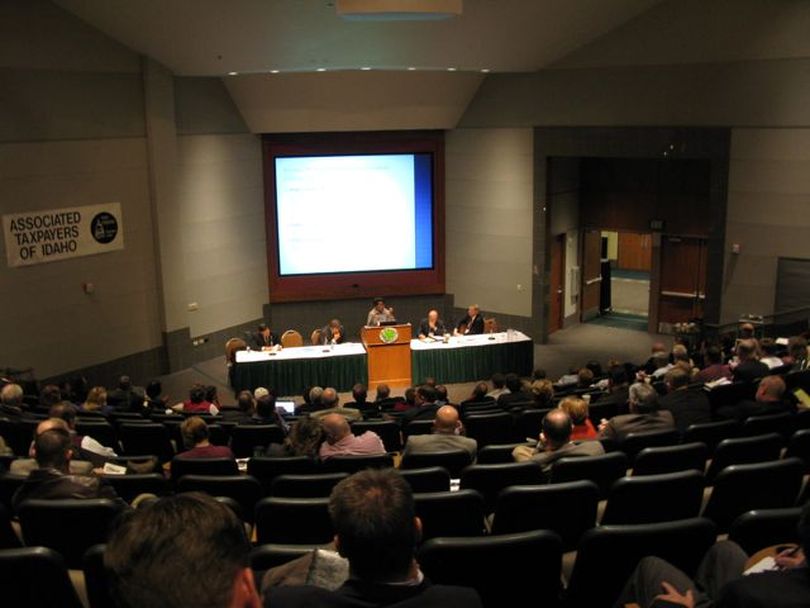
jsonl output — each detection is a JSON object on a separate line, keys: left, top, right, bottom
{"left": 728, "top": 507, "right": 802, "bottom": 555}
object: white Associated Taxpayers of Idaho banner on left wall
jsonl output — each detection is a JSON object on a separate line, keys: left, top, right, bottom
{"left": 3, "top": 203, "right": 124, "bottom": 267}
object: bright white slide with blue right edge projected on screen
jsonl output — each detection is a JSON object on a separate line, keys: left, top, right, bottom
{"left": 275, "top": 154, "right": 433, "bottom": 276}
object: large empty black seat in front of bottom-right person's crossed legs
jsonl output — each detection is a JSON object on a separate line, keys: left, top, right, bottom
{"left": 566, "top": 518, "right": 717, "bottom": 608}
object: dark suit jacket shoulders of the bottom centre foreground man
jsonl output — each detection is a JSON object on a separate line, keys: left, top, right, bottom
{"left": 264, "top": 579, "right": 481, "bottom": 608}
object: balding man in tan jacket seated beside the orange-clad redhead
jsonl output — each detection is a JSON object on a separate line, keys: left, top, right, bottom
{"left": 512, "top": 408, "right": 605, "bottom": 475}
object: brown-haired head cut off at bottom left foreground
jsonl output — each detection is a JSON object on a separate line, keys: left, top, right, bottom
{"left": 104, "top": 492, "right": 261, "bottom": 608}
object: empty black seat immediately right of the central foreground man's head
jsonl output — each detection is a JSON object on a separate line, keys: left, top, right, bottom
{"left": 414, "top": 490, "right": 484, "bottom": 539}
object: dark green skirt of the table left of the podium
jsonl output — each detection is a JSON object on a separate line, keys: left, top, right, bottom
{"left": 231, "top": 354, "right": 368, "bottom": 395}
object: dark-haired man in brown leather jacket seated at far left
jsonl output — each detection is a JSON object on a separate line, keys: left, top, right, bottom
{"left": 11, "top": 420, "right": 120, "bottom": 512}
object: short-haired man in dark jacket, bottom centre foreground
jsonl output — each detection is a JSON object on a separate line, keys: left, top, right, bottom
{"left": 264, "top": 469, "right": 481, "bottom": 608}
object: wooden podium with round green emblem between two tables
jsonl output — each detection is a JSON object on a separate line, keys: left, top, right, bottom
{"left": 360, "top": 323, "right": 411, "bottom": 389}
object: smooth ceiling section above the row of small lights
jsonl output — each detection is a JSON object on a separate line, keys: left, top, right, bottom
{"left": 55, "top": 0, "right": 660, "bottom": 76}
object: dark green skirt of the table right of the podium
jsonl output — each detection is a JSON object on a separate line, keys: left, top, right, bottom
{"left": 411, "top": 340, "right": 534, "bottom": 384}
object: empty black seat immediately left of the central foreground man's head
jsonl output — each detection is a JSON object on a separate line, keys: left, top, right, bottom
{"left": 251, "top": 496, "right": 334, "bottom": 545}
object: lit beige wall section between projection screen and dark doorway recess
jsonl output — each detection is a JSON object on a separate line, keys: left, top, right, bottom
{"left": 445, "top": 129, "right": 534, "bottom": 317}
